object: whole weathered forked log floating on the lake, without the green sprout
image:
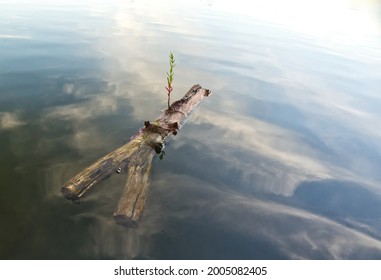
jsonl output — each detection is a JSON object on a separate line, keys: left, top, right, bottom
{"left": 61, "top": 85, "right": 210, "bottom": 225}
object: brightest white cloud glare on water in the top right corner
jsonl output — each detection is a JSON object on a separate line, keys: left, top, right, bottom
{"left": 209, "top": 0, "right": 380, "bottom": 51}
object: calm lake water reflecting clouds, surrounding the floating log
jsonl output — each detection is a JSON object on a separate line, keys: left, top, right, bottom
{"left": 0, "top": 0, "right": 381, "bottom": 259}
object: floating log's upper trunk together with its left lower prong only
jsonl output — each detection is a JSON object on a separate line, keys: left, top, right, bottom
{"left": 61, "top": 85, "right": 210, "bottom": 201}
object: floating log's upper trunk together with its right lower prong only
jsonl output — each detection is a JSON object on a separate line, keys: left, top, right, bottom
{"left": 114, "top": 85, "right": 210, "bottom": 226}
